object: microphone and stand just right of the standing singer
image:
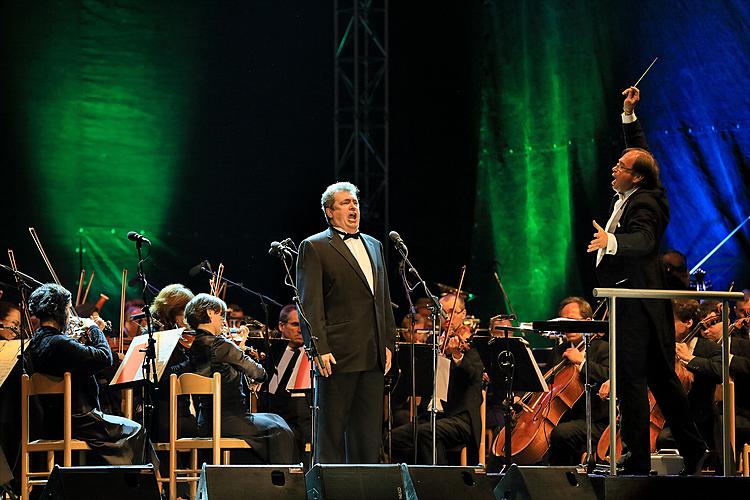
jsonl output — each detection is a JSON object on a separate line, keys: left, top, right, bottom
{"left": 396, "top": 238, "right": 444, "bottom": 465}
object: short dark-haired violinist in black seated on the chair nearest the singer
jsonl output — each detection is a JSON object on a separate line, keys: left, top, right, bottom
{"left": 185, "top": 293, "right": 296, "bottom": 464}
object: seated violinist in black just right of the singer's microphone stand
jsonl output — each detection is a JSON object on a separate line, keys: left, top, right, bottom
{"left": 391, "top": 294, "right": 484, "bottom": 465}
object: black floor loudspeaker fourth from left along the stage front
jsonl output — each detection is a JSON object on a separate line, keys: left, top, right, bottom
{"left": 409, "top": 465, "right": 495, "bottom": 500}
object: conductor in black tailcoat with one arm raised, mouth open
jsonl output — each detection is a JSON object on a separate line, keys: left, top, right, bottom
{"left": 588, "top": 87, "right": 708, "bottom": 474}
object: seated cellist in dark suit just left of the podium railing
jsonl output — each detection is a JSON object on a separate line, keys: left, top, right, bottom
{"left": 549, "top": 297, "right": 609, "bottom": 465}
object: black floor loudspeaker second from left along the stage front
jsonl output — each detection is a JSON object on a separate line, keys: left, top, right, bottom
{"left": 197, "top": 464, "right": 307, "bottom": 500}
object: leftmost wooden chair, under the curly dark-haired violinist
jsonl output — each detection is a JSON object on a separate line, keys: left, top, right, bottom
{"left": 21, "top": 372, "right": 91, "bottom": 500}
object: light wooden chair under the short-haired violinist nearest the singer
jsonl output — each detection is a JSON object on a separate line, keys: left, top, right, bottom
{"left": 168, "top": 372, "right": 250, "bottom": 500}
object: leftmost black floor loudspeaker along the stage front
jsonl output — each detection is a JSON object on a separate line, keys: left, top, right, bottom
{"left": 42, "top": 465, "right": 159, "bottom": 500}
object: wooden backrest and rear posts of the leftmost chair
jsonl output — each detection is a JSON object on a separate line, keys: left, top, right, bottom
{"left": 21, "top": 372, "right": 73, "bottom": 467}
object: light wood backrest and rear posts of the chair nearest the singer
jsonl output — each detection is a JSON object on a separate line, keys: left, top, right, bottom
{"left": 169, "top": 372, "right": 221, "bottom": 465}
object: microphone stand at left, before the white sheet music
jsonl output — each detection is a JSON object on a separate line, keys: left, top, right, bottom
{"left": 130, "top": 239, "right": 159, "bottom": 463}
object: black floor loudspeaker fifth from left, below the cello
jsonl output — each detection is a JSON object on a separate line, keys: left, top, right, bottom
{"left": 495, "top": 464, "right": 597, "bottom": 500}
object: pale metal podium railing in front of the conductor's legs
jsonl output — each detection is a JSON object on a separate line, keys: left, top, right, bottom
{"left": 594, "top": 288, "right": 744, "bottom": 476}
